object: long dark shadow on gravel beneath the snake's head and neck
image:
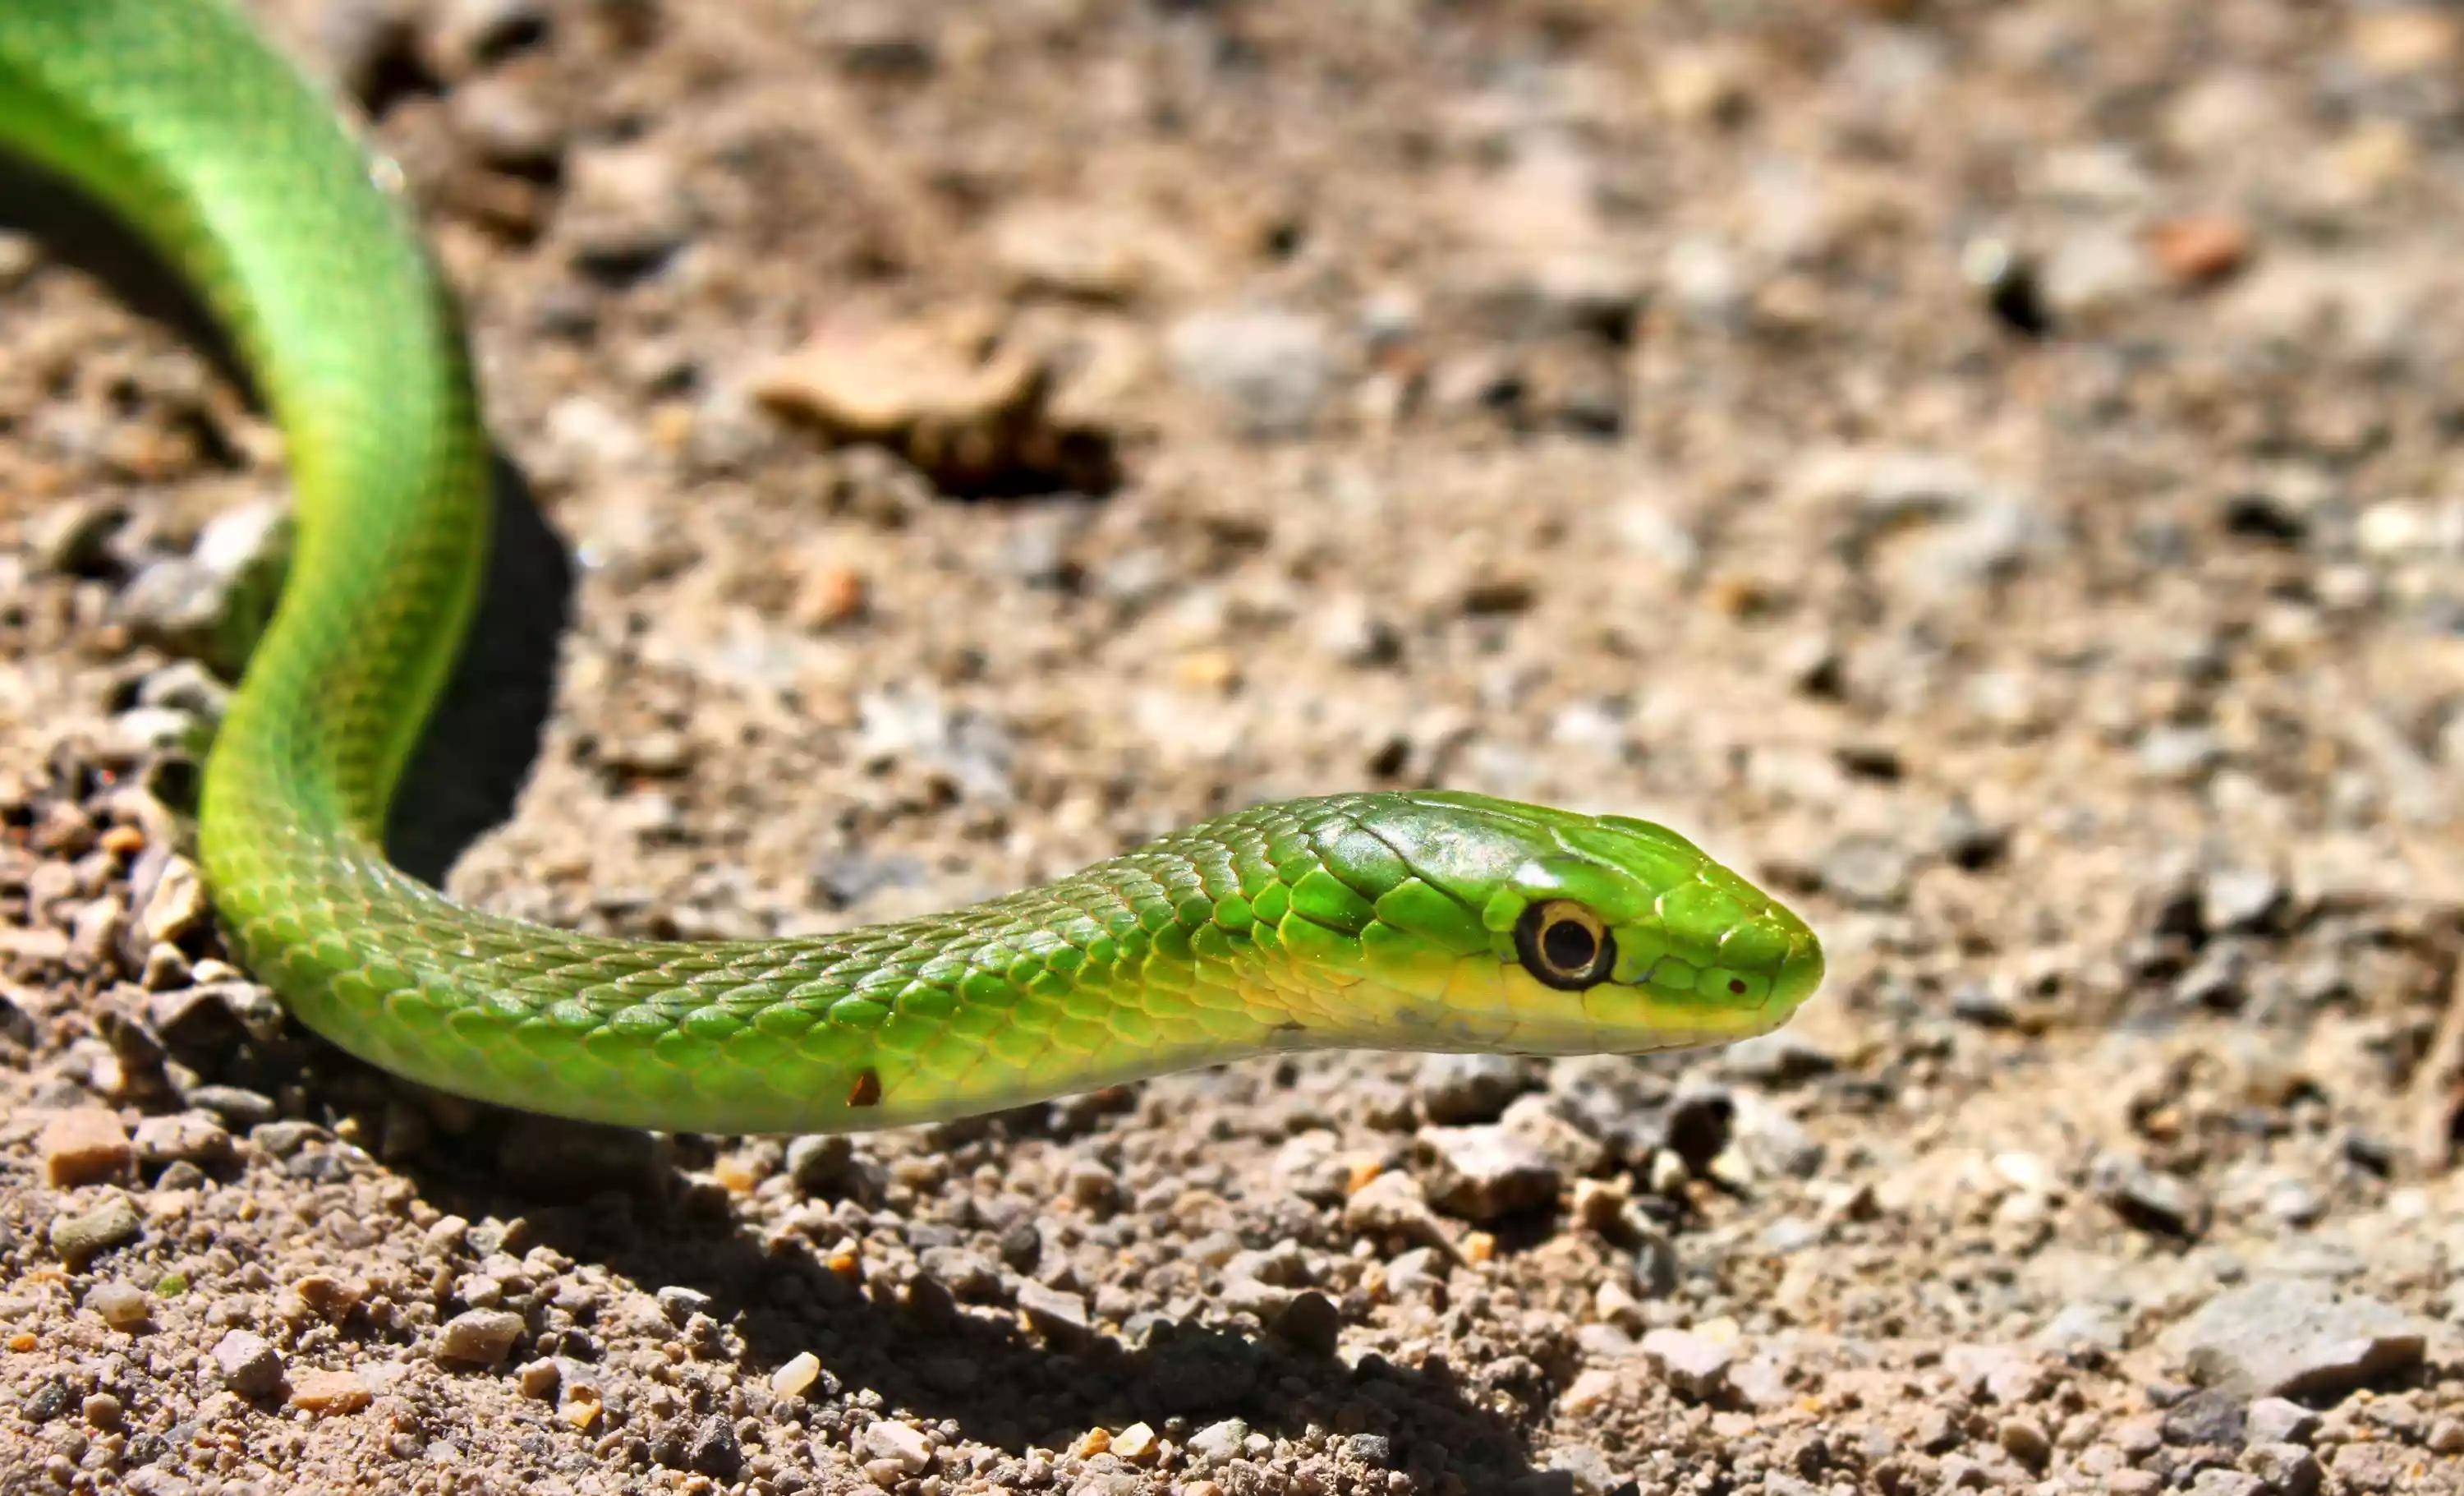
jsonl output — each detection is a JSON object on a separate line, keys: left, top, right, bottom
{"left": 409, "top": 1134, "right": 1574, "bottom": 1496}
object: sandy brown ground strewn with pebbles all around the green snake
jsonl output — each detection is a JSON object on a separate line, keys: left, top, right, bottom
{"left": 0, "top": 0, "right": 2464, "bottom": 1496}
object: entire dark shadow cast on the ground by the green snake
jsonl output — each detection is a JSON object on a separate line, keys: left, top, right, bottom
{"left": 0, "top": 155, "right": 1572, "bottom": 1496}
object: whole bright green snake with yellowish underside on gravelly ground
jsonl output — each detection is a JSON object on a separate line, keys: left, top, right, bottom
{"left": 0, "top": 0, "right": 1823, "bottom": 1134}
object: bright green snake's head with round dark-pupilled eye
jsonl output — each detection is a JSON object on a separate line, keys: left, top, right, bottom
{"left": 1311, "top": 794, "right": 1823, "bottom": 1055}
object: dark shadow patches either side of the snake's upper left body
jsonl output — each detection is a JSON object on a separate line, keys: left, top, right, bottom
{"left": 0, "top": 153, "right": 574, "bottom": 885}
